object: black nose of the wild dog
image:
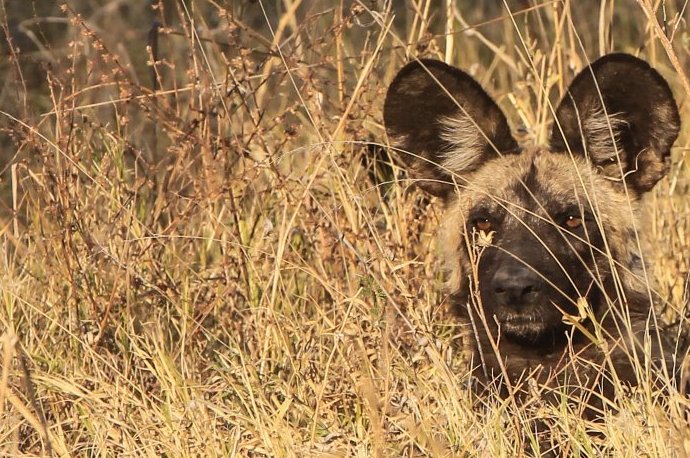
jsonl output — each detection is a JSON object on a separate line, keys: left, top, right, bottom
{"left": 491, "top": 265, "right": 544, "bottom": 309}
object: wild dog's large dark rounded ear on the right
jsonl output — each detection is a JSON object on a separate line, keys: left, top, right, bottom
{"left": 551, "top": 54, "right": 680, "bottom": 195}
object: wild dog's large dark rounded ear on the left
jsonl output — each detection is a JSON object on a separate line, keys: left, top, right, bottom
{"left": 383, "top": 59, "right": 517, "bottom": 197}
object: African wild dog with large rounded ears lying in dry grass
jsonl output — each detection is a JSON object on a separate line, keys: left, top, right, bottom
{"left": 384, "top": 54, "right": 680, "bottom": 402}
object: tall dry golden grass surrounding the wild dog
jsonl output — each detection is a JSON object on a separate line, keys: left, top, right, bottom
{"left": 0, "top": 0, "right": 690, "bottom": 457}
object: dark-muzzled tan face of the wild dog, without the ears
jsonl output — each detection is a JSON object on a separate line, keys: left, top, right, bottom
{"left": 452, "top": 149, "right": 620, "bottom": 346}
